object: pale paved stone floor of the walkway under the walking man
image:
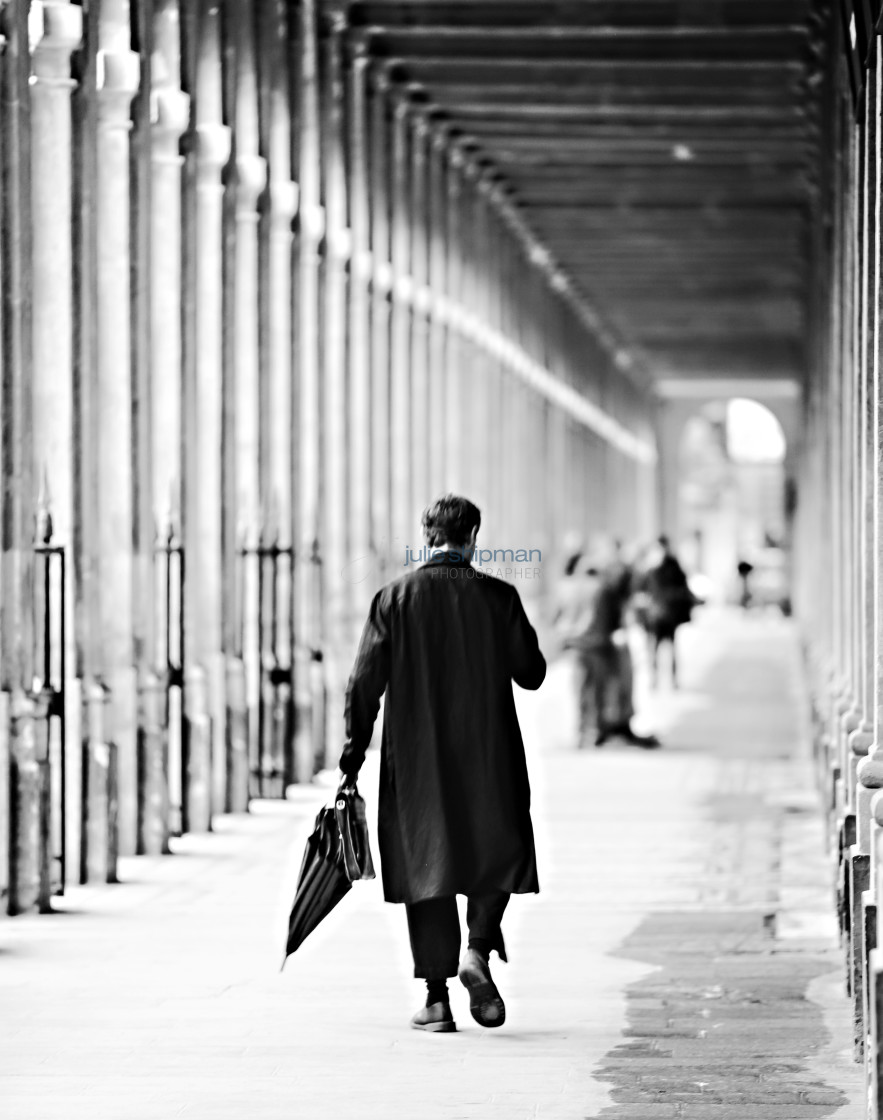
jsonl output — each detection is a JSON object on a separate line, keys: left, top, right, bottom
{"left": 0, "top": 614, "right": 863, "bottom": 1120}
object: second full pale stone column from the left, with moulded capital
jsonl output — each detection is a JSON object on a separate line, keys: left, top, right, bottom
{"left": 94, "top": 15, "right": 140, "bottom": 855}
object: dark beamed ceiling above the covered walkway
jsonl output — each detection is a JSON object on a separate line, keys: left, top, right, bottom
{"left": 351, "top": 0, "right": 818, "bottom": 392}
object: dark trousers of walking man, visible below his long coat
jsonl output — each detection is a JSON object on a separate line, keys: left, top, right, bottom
{"left": 405, "top": 890, "right": 509, "bottom": 980}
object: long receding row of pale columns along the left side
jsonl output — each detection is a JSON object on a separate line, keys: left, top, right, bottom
{"left": 0, "top": 0, "right": 654, "bottom": 912}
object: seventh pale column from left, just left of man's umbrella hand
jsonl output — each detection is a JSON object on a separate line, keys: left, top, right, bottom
{"left": 295, "top": 0, "right": 325, "bottom": 781}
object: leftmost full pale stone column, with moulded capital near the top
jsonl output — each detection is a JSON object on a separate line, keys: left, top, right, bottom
{"left": 28, "top": 0, "right": 83, "bottom": 891}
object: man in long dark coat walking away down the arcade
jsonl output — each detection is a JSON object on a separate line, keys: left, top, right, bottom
{"left": 341, "top": 495, "right": 546, "bottom": 1032}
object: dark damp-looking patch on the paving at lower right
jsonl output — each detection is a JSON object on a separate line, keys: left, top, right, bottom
{"left": 587, "top": 911, "right": 849, "bottom": 1120}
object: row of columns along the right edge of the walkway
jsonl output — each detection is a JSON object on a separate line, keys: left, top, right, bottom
{"left": 794, "top": 10, "right": 883, "bottom": 1118}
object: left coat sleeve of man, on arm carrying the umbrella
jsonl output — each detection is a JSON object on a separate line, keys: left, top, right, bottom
{"left": 340, "top": 591, "right": 390, "bottom": 777}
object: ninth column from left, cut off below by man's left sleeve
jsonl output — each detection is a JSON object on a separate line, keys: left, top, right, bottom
{"left": 345, "top": 38, "right": 372, "bottom": 622}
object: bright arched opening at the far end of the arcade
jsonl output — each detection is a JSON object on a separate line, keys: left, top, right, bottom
{"left": 678, "top": 398, "right": 790, "bottom": 612}
